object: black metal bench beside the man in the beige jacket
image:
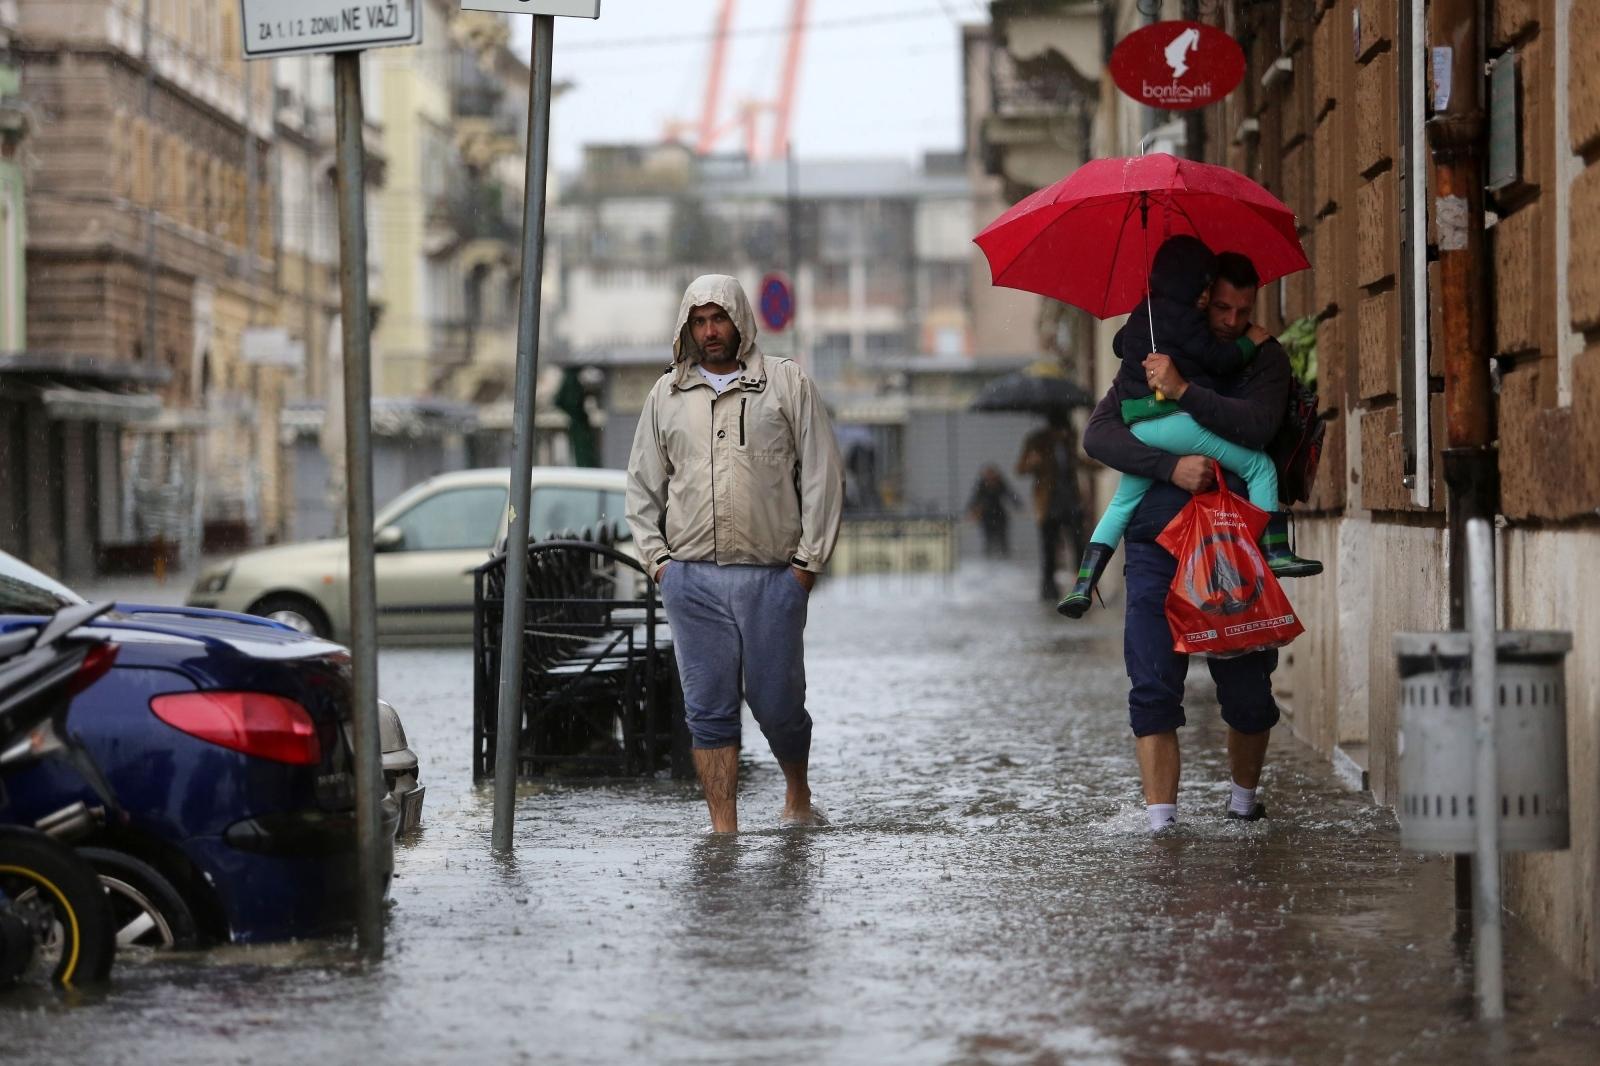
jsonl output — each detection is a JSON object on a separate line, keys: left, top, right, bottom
{"left": 472, "top": 530, "right": 693, "bottom": 781}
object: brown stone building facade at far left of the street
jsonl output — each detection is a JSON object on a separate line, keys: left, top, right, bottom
{"left": 10, "top": 0, "right": 283, "bottom": 573}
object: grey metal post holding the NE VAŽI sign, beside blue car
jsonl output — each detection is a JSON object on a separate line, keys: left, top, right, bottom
{"left": 333, "top": 51, "right": 384, "bottom": 959}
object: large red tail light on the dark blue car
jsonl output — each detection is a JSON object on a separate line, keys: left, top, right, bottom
{"left": 150, "top": 691, "right": 322, "bottom": 767}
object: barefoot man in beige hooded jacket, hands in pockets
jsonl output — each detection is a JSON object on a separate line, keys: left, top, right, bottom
{"left": 627, "top": 274, "right": 843, "bottom": 832}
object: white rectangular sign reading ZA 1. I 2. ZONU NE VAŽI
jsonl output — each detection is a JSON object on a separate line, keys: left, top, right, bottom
{"left": 238, "top": 0, "right": 426, "bottom": 59}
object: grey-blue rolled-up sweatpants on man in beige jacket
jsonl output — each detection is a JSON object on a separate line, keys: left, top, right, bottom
{"left": 661, "top": 560, "right": 811, "bottom": 762}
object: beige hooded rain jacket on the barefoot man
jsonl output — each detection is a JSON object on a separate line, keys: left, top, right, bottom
{"left": 627, "top": 274, "right": 845, "bottom": 573}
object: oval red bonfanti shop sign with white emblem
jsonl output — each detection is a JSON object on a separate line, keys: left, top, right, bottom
{"left": 1110, "top": 22, "right": 1245, "bottom": 110}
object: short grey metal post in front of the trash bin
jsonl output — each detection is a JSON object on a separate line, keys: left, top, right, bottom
{"left": 1467, "top": 519, "right": 1506, "bottom": 1021}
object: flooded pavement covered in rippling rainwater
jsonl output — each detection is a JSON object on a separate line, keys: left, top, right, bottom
{"left": 0, "top": 568, "right": 1600, "bottom": 1066}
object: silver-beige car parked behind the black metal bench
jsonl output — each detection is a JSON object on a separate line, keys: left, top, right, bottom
{"left": 187, "top": 467, "right": 627, "bottom": 643}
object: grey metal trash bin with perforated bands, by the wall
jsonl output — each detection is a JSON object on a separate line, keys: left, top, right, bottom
{"left": 1394, "top": 629, "right": 1573, "bottom": 853}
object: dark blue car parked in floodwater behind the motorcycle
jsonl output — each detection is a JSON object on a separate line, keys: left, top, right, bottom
{"left": 0, "top": 552, "right": 422, "bottom": 946}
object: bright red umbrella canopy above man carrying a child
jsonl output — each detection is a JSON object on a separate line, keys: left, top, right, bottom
{"left": 973, "top": 154, "right": 1310, "bottom": 319}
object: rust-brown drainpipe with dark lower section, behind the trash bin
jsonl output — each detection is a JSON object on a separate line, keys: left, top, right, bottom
{"left": 1418, "top": 0, "right": 1499, "bottom": 911}
